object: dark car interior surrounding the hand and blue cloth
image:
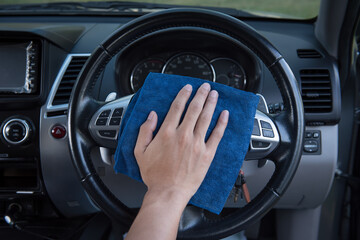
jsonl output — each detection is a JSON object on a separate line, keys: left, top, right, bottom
{"left": 0, "top": 0, "right": 360, "bottom": 240}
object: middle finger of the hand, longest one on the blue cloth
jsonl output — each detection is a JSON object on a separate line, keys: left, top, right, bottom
{"left": 181, "top": 83, "right": 210, "bottom": 131}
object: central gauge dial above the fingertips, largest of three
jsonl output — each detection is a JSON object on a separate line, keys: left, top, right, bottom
{"left": 163, "top": 53, "right": 215, "bottom": 81}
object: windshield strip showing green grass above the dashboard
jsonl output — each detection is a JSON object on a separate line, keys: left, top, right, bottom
{"left": 0, "top": 0, "right": 321, "bottom": 19}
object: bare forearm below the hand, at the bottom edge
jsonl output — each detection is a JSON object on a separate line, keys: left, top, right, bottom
{"left": 126, "top": 190, "right": 190, "bottom": 240}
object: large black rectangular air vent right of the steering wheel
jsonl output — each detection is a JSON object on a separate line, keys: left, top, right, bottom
{"left": 300, "top": 69, "right": 332, "bottom": 113}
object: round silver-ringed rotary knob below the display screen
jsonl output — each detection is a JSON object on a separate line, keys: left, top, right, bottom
{"left": 3, "top": 118, "right": 31, "bottom": 145}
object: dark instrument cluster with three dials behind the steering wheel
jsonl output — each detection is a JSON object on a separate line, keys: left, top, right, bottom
{"left": 114, "top": 31, "right": 263, "bottom": 96}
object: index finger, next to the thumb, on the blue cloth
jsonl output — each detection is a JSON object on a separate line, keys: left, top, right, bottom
{"left": 161, "top": 84, "right": 192, "bottom": 128}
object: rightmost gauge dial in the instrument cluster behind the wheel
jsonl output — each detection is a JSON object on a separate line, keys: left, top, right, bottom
{"left": 211, "top": 58, "right": 246, "bottom": 90}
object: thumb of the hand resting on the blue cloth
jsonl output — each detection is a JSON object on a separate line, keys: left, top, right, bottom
{"left": 134, "top": 111, "right": 157, "bottom": 157}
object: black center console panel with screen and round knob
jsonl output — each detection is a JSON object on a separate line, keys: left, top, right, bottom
{"left": 0, "top": 33, "right": 44, "bottom": 199}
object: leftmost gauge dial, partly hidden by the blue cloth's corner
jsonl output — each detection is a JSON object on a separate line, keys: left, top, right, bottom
{"left": 130, "top": 59, "right": 164, "bottom": 92}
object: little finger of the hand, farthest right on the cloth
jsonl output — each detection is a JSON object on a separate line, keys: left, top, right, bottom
{"left": 206, "top": 110, "right": 229, "bottom": 151}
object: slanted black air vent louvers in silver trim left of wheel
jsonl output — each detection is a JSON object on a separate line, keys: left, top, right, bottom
{"left": 52, "top": 56, "right": 88, "bottom": 105}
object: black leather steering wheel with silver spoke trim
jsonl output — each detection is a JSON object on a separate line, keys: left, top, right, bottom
{"left": 68, "top": 9, "right": 304, "bottom": 239}
